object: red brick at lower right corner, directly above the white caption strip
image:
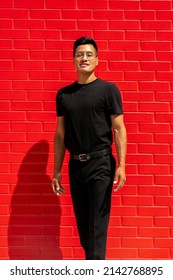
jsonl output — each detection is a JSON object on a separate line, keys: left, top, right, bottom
{"left": 139, "top": 248, "right": 170, "bottom": 260}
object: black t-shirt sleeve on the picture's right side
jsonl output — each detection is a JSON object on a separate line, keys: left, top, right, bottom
{"left": 107, "top": 84, "right": 123, "bottom": 115}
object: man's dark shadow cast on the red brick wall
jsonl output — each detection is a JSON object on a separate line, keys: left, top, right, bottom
{"left": 8, "top": 141, "right": 62, "bottom": 260}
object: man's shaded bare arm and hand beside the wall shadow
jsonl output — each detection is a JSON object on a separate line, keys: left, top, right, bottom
{"left": 52, "top": 116, "right": 66, "bottom": 195}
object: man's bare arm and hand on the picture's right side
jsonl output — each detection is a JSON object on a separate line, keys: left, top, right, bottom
{"left": 111, "top": 114, "right": 127, "bottom": 191}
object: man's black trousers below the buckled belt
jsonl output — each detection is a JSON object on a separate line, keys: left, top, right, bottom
{"left": 69, "top": 154, "right": 115, "bottom": 260}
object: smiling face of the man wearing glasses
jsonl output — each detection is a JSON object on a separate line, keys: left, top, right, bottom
{"left": 73, "top": 44, "right": 98, "bottom": 73}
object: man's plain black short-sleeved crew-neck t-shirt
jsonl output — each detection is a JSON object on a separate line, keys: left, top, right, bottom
{"left": 56, "top": 79, "right": 123, "bottom": 155}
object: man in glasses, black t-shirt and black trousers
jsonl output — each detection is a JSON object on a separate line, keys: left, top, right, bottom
{"left": 52, "top": 37, "right": 127, "bottom": 260}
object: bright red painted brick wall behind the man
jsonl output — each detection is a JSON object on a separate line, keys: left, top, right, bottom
{"left": 0, "top": 0, "right": 173, "bottom": 259}
